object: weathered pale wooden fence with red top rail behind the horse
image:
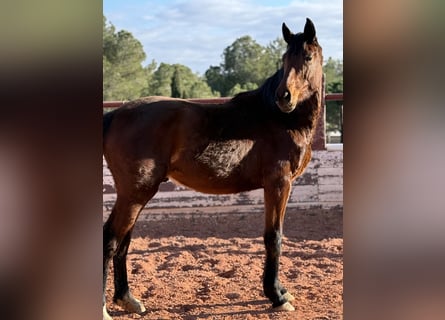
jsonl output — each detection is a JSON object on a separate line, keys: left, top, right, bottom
{"left": 103, "top": 93, "right": 343, "bottom": 219}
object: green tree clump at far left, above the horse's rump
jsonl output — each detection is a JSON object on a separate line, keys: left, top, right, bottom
{"left": 102, "top": 16, "right": 218, "bottom": 100}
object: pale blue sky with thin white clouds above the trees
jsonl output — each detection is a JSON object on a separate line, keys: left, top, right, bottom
{"left": 103, "top": 0, "right": 343, "bottom": 75}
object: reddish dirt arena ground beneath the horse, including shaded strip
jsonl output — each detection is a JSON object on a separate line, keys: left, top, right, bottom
{"left": 107, "top": 208, "right": 343, "bottom": 320}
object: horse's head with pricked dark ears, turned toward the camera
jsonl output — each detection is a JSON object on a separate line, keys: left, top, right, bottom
{"left": 275, "top": 18, "right": 323, "bottom": 113}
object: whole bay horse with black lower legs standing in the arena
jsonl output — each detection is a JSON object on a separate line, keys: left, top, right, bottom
{"left": 103, "top": 18, "right": 323, "bottom": 319}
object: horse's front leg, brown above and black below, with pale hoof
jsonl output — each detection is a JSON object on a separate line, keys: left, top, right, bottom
{"left": 263, "top": 178, "right": 295, "bottom": 311}
